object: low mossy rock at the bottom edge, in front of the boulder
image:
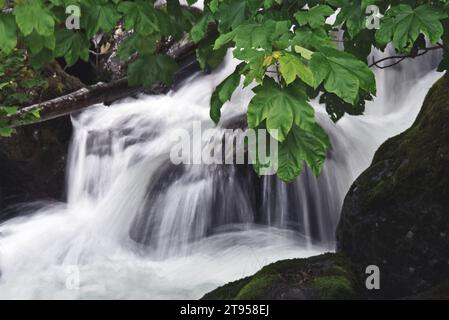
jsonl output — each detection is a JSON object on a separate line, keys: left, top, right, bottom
{"left": 202, "top": 253, "right": 360, "bottom": 300}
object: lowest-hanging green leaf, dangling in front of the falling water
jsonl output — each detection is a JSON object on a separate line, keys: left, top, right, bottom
{"left": 277, "top": 123, "right": 330, "bottom": 182}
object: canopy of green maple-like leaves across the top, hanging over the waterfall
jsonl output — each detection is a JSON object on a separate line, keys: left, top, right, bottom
{"left": 0, "top": 0, "right": 449, "bottom": 181}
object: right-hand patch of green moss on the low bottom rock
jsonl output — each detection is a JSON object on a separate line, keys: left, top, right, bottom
{"left": 311, "top": 276, "right": 355, "bottom": 300}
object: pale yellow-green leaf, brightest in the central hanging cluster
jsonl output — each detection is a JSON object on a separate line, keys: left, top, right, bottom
{"left": 279, "top": 52, "right": 314, "bottom": 87}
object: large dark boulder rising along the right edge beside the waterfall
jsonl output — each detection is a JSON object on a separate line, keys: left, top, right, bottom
{"left": 337, "top": 75, "right": 449, "bottom": 298}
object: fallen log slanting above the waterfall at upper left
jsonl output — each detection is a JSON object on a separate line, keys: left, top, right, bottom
{"left": 7, "top": 41, "right": 199, "bottom": 128}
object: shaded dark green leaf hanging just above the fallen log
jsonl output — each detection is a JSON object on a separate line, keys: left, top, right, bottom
{"left": 128, "top": 54, "right": 178, "bottom": 88}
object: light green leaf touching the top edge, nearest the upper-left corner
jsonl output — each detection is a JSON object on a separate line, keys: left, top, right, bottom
{"left": 14, "top": 0, "right": 55, "bottom": 37}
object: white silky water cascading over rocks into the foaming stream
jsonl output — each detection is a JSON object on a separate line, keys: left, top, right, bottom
{"left": 0, "top": 49, "right": 439, "bottom": 299}
